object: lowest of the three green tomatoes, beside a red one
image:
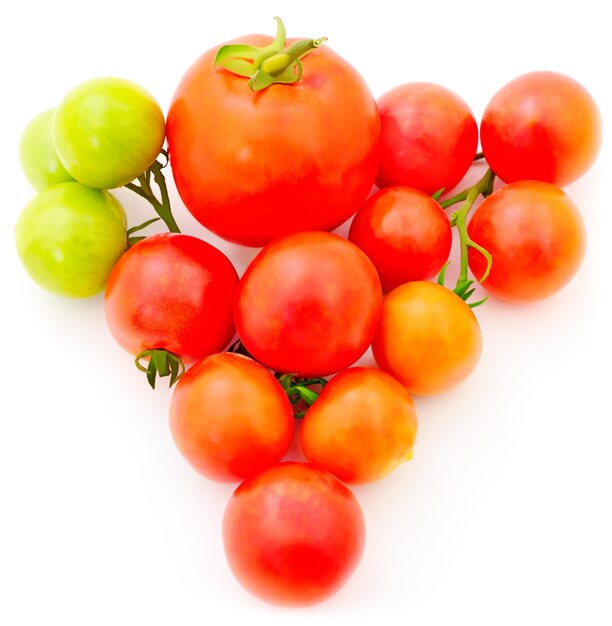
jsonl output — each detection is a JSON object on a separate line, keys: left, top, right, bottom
{"left": 15, "top": 182, "right": 126, "bottom": 298}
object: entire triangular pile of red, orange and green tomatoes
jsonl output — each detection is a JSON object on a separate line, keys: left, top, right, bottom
{"left": 15, "top": 18, "right": 601, "bottom": 605}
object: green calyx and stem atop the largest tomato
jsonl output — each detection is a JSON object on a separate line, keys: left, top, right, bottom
{"left": 214, "top": 17, "right": 327, "bottom": 92}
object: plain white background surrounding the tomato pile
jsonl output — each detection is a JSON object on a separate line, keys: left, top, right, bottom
{"left": 0, "top": 0, "right": 612, "bottom": 626}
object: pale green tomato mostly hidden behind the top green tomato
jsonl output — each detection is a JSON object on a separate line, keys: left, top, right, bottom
{"left": 19, "top": 109, "right": 74, "bottom": 191}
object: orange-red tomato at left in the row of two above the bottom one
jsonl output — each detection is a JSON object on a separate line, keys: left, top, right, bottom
{"left": 170, "top": 352, "right": 294, "bottom": 482}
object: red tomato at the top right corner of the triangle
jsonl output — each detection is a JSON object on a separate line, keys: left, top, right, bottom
{"left": 480, "top": 72, "right": 601, "bottom": 187}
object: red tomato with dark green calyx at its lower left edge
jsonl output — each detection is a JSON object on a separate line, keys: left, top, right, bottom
{"left": 105, "top": 233, "right": 238, "bottom": 362}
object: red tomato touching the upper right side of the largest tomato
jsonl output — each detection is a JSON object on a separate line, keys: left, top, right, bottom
{"left": 376, "top": 83, "right": 478, "bottom": 194}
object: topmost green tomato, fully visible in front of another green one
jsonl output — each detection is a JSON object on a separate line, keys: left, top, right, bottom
{"left": 53, "top": 78, "right": 165, "bottom": 189}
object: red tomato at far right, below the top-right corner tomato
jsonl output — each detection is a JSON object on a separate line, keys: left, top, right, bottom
{"left": 468, "top": 181, "right": 586, "bottom": 302}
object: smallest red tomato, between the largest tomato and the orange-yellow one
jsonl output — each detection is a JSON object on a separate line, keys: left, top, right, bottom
{"left": 349, "top": 187, "right": 452, "bottom": 291}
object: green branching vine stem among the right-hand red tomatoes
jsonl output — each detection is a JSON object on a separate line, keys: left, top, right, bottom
{"left": 433, "top": 167, "right": 495, "bottom": 309}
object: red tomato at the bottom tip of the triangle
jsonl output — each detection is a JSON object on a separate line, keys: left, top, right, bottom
{"left": 223, "top": 463, "right": 365, "bottom": 606}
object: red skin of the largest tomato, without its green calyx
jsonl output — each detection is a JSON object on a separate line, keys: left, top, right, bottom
{"left": 167, "top": 35, "right": 380, "bottom": 246}
